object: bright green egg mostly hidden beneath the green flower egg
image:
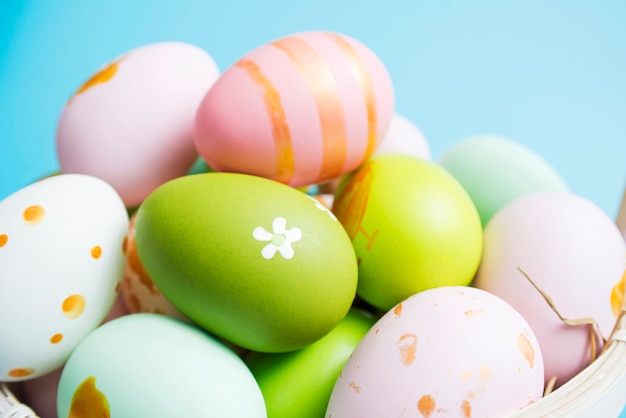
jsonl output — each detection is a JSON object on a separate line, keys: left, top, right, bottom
{"left": 244, "top": 308, "right": 377, "bottom": 418}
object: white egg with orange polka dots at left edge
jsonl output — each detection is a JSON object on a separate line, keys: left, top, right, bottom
{"left": 0, "top": 174, "right": 129, "bottom": 381}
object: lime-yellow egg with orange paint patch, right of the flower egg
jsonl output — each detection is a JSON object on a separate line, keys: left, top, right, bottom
{"left": 333, "top": 154, "right": 482, "bottom": 310}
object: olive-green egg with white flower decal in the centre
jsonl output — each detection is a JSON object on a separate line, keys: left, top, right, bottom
{"left": 135, "top": 173, "right": 358, "bottom": 352}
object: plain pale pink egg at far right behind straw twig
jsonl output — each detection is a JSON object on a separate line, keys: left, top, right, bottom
{"left": 474, "top": 191, "right": 626, "bottom": 387}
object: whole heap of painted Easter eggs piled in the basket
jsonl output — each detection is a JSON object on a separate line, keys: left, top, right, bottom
{"left": 0, "top": 31, "right": 626, "bottom": 418}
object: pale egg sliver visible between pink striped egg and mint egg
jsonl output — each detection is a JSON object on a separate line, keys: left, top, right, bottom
{"left": 373, "top": 113, "right": 431, "bottom": 160}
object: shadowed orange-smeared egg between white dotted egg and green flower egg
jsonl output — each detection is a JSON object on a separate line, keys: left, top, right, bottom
{"left": 120, "top": 212, "right": 188, "bottom": 320}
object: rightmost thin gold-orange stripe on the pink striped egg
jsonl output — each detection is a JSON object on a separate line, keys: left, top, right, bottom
{"left": 326, "top": 33, "right": 378, "bottom": 160}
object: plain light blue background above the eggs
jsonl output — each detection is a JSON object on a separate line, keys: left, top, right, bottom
{"left": 0, "top": 0, "right": 626, "bottom": 218}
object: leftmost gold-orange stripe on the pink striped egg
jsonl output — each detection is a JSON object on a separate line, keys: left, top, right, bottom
{"left": 235, "top": 59, "right": 295, "bottom": 184}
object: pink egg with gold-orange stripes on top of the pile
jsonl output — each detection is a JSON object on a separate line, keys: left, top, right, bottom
{"left": 194, "top": 31, "right": 394, "bottom": 187}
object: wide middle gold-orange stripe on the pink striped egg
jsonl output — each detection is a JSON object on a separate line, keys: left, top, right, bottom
{"left": 272, "top": 36, "right": 348, "bottom": 180}
